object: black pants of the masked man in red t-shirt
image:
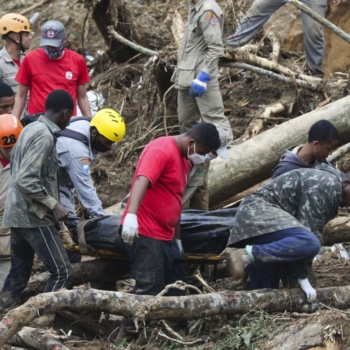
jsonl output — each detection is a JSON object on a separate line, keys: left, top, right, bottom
{"left": 130, "top": 235, "right": 187, "bottom": 296}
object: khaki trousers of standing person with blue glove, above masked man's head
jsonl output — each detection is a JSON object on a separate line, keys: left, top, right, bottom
{"left": 177, "top": 85, "right": 233, "bottom": 145}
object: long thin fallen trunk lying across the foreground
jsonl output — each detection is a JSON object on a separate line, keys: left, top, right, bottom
{"left": 0, "top": 286, "right": 350, "bottom": 346}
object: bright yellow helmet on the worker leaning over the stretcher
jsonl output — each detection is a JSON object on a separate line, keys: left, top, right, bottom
{"left": 90, "top": 108, "right": 125, "bottom": 142}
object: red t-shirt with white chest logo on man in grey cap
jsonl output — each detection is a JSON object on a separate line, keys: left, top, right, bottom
{"left": 16, "top": 48, "right": 90, "bottom": 116}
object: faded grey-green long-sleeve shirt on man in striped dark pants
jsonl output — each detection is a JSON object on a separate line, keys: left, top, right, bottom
{"left": 3, "top": 116, "right": 60, "bottom": 228}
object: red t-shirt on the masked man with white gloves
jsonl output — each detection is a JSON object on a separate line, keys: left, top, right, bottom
{"left": 121, "top": 136, "right": 190, "bottom": 241}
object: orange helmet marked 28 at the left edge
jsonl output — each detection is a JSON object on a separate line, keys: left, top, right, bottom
{"left": 0, "top": 114, "right": 23, "bottom": 148}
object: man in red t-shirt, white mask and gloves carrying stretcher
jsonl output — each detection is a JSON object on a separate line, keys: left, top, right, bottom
{"left": 121, "top": 123, "right": 227, "bottom": 295}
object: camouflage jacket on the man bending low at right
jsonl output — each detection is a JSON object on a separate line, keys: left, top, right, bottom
{"left": 227, "top": 163, "right": 342, "bottom": 278}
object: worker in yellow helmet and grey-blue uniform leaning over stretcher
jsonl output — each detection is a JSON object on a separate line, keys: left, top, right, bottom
{"left": 56, "top": 108, "right": 125, "bottom": 232}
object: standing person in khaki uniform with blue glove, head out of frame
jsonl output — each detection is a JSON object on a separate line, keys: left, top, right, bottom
{"left": 172, "top": 0, "right": 233, "bottom": 210}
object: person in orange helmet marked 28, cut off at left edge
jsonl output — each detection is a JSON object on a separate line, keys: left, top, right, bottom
{"left": 0, "top": 113, "right": 23, "bottom": 289}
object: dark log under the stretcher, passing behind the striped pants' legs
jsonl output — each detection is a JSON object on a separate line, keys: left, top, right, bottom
{"left": 27, "top": 259, "right": 130, "bottom": 294}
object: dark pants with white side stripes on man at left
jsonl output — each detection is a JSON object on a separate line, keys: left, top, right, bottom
{"left": 2, "top": 226, "right": 73, "bottom": 299}
